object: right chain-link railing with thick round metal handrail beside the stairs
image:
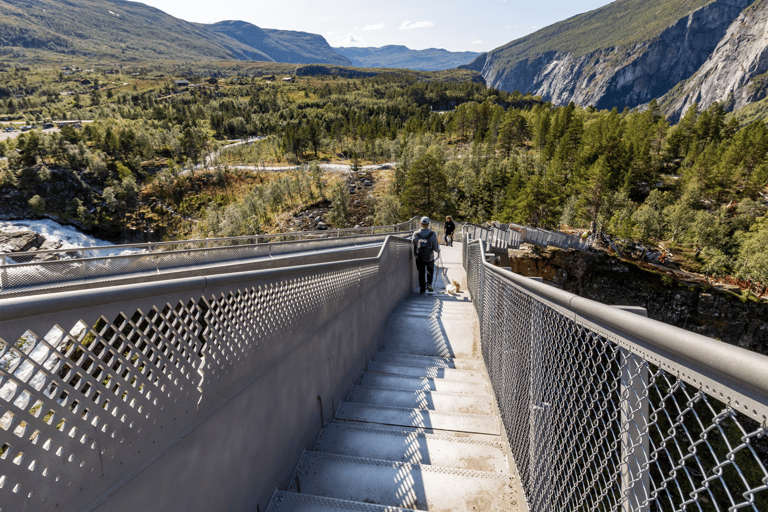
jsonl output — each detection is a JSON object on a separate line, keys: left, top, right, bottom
{"left": 464, "top": 236, "right": 768, "bottom": 512}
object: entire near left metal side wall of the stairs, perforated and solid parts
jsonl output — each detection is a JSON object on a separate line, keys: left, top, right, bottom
{"left": 0, "top": 236, "right": 413, "bottom": 512}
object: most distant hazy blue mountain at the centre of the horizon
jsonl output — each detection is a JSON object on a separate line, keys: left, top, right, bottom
{"left": 334, "top": 45, "right": 480, "bottom": 71}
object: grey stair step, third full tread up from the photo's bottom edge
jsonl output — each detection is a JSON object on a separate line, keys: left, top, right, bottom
{"left": 336, "top": 402, "right": 500, "bottom": 435}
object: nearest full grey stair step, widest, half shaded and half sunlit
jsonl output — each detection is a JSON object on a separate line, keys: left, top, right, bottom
{"left": 288, "top": 452, "right": 513, "bottom": 512}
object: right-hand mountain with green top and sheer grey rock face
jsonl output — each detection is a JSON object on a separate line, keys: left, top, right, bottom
{"left": 461, "top": 0, "right": 766, "bottom": 118}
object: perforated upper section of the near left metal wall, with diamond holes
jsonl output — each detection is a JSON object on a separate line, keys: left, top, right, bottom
{"left": 0, "top": 239, "right": 411, "bottom": 512}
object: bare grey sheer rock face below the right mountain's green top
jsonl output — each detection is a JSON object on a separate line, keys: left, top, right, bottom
{"left": 468, "top": 0, "right": 765, "bottom": 116}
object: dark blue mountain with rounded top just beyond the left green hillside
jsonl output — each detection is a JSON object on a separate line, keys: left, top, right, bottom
{"left": 207, "top": 21, "right": 352, "bottom": 66}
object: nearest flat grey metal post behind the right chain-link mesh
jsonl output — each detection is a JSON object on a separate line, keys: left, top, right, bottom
{"left": 615, "top": 306, "right": 650, "bottom": 512}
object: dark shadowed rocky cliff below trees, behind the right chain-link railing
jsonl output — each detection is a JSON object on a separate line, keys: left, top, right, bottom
{"left": 510, "top": 249, "right": 768, "bottom": 355}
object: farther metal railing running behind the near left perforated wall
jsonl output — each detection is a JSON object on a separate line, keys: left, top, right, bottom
{"left": 0, "top": 220, "right": 415, "bottom": 296}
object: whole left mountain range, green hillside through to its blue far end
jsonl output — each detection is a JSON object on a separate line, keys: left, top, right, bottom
{"left": 0, "top": 0, "right": 350, "bottom": 65}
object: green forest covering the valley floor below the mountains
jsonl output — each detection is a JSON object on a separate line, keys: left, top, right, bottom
{"left": 0, "top": 66, "right": 768, "bottom": 292}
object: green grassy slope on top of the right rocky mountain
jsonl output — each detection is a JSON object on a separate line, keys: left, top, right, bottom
{"left": 469, "top": 0, "right": 712, "bottom": 69}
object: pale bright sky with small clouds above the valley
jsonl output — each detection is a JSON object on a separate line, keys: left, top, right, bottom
{"left": 129, "top": 0, "right": 611, "bottom": 52}
